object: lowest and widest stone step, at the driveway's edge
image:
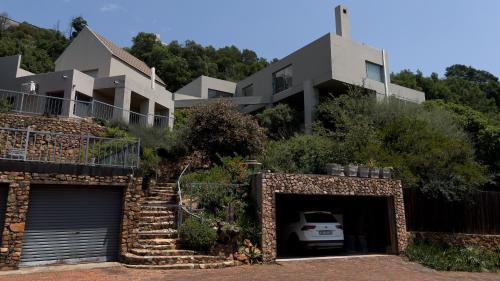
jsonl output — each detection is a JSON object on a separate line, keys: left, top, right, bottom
{"left": 124, "top": 253, "right": 225, "bottom": 265}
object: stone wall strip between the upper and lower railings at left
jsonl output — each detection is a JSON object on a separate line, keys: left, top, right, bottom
{"left": 0, "top": 113, "right": 104, "bottom": 136}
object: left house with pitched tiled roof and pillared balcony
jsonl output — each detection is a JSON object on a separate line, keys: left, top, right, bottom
{"left": 0, "top": 27, "right": 174, "bottom": 127}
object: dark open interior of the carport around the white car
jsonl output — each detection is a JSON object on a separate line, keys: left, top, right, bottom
{"left": 276, "top": 193, "right": 397, "bottom": 258}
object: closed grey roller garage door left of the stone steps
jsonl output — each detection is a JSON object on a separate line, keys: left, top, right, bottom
{"left": 21, "top": 186, "right": 122, "bottom": 266}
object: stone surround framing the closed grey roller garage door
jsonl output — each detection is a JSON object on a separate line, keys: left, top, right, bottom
{"left": 0, "top": 171, "right": 144, "bottom": 269}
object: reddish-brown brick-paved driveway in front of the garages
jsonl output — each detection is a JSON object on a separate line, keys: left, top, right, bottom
{"left": 0, "top": 256, "right": 500, "bottom": 281}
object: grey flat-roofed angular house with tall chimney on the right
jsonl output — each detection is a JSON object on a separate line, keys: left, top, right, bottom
{"left": 175, "top": 6, "right": 425, "bottom": 131}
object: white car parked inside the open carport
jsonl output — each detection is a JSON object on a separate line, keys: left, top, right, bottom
{"left": 284, "top": 211, "right": 344, "bottom": 250}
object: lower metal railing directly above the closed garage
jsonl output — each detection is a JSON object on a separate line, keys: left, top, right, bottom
{"left": 0, "top": 128, "right": 140, "bottom": 168}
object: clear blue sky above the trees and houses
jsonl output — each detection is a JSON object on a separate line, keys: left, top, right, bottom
{"left": 0, "top": 0, "right": 500, "bottom": 76}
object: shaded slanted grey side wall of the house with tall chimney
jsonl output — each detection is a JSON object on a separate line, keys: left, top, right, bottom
{"left": 236, "top": 34, "right": 332, "bottom": 101}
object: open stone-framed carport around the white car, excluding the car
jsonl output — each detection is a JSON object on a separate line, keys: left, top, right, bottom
{"left": 253, "top": 173, "right": 407, "bottom": 262}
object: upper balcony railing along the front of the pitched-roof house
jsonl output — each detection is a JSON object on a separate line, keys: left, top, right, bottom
{"left": 0, "top": 90, "right": 172, "bottom": 128}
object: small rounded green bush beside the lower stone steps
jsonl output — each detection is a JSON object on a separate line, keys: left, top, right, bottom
{"left": 180, "top": 218, "right": 217, "bottom": 252}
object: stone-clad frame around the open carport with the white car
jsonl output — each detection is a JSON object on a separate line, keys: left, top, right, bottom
{"left": 253, "top": 173, "right": 407, "bottom": 262}
